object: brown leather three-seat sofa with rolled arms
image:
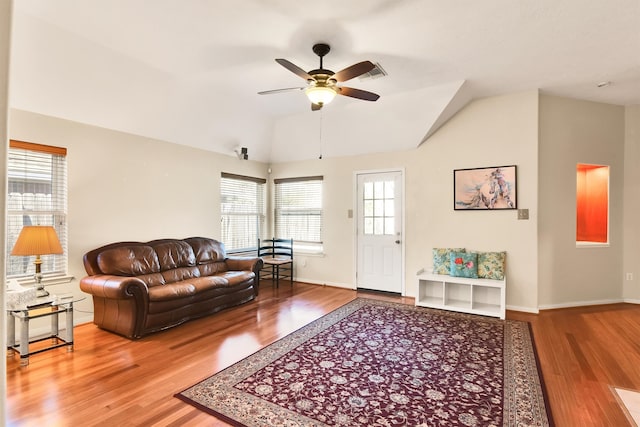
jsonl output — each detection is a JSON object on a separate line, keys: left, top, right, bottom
{"left": 80, "top": 237, "right": 262, "bottom": 339}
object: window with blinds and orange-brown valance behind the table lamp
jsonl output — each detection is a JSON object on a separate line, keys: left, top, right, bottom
{"left": 6, "top": 140, "right": 68, "bottom": 278}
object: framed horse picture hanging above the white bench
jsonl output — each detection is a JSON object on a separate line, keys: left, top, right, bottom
{"left": 453, "top": 165, "right": 518, "bottom": 211}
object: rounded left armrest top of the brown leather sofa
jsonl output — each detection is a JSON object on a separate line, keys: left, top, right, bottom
{"left": 80, "top": 274, "right": 149, "bottom": 305}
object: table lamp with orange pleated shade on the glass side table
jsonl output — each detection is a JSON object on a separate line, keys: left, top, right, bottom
{"left": 11, "top": 225, "right": 63, "bottom": 297}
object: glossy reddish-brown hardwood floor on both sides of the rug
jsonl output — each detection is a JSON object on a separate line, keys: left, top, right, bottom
{"left": 6, "top": 283, "right": 640, "bottom": 426}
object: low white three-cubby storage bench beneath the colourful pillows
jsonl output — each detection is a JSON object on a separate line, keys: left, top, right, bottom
{"left": 416, "top": 271, "right": 507, "bottom": 320}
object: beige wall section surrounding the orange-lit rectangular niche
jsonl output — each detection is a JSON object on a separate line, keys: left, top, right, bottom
{"left": 538, "top": 96, "right": 624, "bottom": 308}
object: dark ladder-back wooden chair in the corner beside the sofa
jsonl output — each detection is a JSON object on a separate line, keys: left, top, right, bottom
{"left": 258, "top": 238, "right": 293, "bottom": 287}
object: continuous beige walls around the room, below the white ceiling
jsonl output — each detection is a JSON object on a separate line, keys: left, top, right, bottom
{"left": 10, "top": 91, "right": 640, "bottom": 320}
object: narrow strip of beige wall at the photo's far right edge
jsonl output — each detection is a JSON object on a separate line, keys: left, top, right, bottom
{"left": 623, "top": 105, "right": 640, "bottom": 303}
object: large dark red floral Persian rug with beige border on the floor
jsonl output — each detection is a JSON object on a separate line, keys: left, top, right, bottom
{"left": 176, "top": 298, "right": 552, "bottom": 427}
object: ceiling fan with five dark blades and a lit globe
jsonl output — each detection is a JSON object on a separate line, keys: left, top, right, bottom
{"left": 258, "top": 43, "right": 380, "bottom": 111}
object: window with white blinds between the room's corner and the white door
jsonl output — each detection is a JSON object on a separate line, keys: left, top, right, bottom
{"left": 274, "top": 176, "right": 322, "bottom": 252}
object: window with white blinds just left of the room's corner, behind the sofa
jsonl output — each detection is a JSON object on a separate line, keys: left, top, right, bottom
{"left": 220, "top": 172, "right": 267, "bottom": 252}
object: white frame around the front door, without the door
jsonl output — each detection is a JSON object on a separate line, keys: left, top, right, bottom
{"left": 351, "top": 167, "right": 407, "bottom": 296}
